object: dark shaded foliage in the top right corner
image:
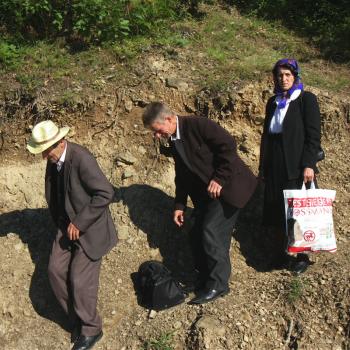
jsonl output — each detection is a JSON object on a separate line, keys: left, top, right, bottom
{"left": 234, "top": 0, "right": 350, "bottom": 62}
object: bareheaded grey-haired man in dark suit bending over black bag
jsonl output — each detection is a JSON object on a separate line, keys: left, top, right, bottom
{"left": 143, "top": 102, "right": 257, "bottom": 304}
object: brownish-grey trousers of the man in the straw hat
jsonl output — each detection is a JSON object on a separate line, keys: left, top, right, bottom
{"left": 48, "top": 229, "right": 102, "bottom": 336}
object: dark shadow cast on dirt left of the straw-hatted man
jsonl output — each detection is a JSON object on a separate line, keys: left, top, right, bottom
{"left": 0, "top": 209, "right": 68, "bottom": 330}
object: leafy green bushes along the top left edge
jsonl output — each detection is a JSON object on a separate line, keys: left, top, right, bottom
{"left": 0, "top": 0, "right": 184, "bottom": 44}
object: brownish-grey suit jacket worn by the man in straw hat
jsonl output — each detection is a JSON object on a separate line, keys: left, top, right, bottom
{"left": 45, "top": 141, "right": 117, "bottom": 260}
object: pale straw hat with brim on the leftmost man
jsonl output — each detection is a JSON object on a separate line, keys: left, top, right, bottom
{"left": 27, "top": 120, "right": 69, "bottom": 154}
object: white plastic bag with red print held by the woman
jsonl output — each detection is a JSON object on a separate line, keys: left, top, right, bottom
{"left": 283, "top": 183, "right": 337, "bottom": 253}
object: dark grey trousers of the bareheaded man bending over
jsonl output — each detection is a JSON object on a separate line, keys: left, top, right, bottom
{"left": 189, "top": 199, "right": 239, "bottom": 291}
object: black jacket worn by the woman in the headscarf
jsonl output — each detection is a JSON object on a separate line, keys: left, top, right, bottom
{"left": 259, "top": 91, "right": 321, "bottom": 180}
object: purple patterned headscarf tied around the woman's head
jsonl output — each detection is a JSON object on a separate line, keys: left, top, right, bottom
{"left": 272, "top": 58, "right": 304, "bottom": 108}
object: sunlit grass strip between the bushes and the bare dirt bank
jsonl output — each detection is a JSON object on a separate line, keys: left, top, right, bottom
{"left": 0, "top": 5, "right": 350, "bottom": 100}
